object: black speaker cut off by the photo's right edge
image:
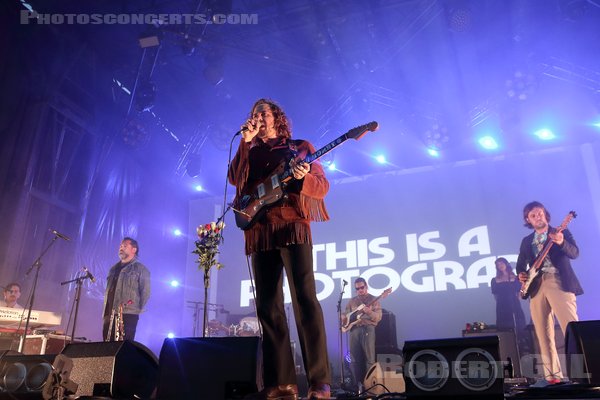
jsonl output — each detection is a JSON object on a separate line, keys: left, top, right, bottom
{"left": 565, "top": 321, "right": 600, "bottom": 386}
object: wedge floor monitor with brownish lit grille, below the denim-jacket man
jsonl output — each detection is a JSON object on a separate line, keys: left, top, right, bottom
{"left": 61, "top": 340, "right": 158, "bottom": 399}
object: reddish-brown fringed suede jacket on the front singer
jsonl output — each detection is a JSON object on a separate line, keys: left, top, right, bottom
{"left": 228, "top": 138, "right": 329, "bottom": 254}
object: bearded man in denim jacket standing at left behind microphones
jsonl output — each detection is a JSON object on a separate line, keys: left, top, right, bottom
{"left": 102, "top": 237, "right": 150, "bottom": 341}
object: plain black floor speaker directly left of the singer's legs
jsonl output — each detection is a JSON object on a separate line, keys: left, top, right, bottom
{"left": 157, "top": 336, "right": 262, "bottom": 400}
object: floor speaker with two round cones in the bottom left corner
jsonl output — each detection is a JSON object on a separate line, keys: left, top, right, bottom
{"left": 0, "top": 351, "right": 56, "bottom": 399}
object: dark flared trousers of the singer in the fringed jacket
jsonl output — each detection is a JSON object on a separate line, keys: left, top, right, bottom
{"left": 252, "top": 244, "right": 331, "bottom": 387}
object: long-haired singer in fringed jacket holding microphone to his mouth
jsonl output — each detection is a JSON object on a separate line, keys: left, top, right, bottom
{"left": 228, "top": 99, "right": 331, "bottom": 400}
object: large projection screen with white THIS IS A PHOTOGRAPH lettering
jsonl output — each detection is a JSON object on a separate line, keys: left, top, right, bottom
{"left": 184, "top": 141, "right": 600, "bottom": 376}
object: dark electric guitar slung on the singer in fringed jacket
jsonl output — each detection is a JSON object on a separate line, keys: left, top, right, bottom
{"left": 231, "top": 121, "right": 379, "bottom": 230}
